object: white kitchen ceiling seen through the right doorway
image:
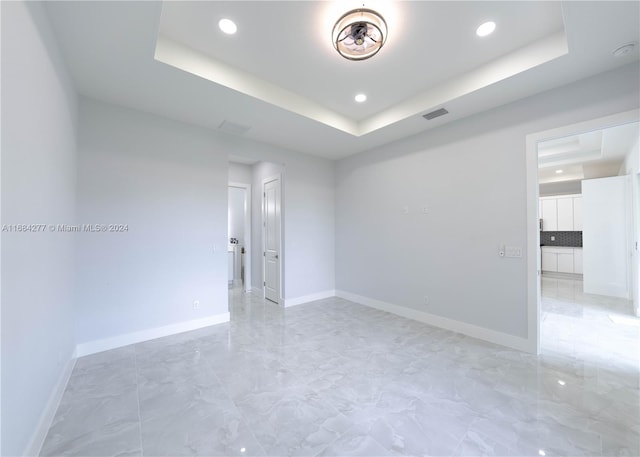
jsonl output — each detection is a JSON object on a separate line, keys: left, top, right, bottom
{"left": 538, "top": 122, "right": 640, "bottom": 184}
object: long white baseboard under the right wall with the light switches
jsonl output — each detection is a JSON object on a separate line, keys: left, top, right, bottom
{"left": 336, "top": 290, "right": 536, "bottom": 354}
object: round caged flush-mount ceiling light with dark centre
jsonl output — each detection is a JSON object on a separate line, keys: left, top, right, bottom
{"left": 332, "top": 8, "right": 387, "bottom": 60}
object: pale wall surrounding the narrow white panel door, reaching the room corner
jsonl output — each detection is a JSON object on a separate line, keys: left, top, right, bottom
{"left": 245, "top": 154, "right": 335, "bottom": 300}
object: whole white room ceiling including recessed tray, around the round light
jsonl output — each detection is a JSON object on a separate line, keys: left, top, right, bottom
{"left": 47, "top": 0, "right": 640, "bottom": 159}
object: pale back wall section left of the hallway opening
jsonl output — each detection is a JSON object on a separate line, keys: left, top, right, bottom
{"left": 76, "top": 98, "right": 228, "bottom": 344}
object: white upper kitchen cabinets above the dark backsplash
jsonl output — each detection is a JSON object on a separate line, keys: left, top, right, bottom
{"left": 540, "top": 195, "right": 582, "bottom": 232}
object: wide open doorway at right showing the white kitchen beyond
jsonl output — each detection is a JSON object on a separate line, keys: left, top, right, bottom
{"left": 527, "top": 110, "right": 640, "bottom": 356}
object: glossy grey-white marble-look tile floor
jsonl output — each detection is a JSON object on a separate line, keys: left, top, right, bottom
{"left": 42, "top": 278, "right": 640, "bottom": 456}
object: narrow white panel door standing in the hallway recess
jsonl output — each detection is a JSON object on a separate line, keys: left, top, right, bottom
{"left": 263, "top": 178, "right": 281, "bottom": 303}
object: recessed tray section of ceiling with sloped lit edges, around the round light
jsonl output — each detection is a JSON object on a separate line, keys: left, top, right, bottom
{"left": 155, "top": 0, "right": 568, "bottom": 136}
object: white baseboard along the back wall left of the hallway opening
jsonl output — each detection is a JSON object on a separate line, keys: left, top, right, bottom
{"left": 76, "top": 313, "right": 230, "bottom": 357}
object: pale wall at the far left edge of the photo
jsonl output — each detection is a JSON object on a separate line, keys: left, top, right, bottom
{"left": 1, "top": 2, "right": 77, "bottom": 456}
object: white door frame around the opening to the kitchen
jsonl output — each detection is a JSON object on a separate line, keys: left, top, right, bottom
{"left": 525, "top": 109, "right": 640, "bottom": 354}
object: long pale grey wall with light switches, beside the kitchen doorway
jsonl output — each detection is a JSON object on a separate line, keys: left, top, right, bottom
{"left": 336, "top": 65, "right": 639, "bottom": 339}
